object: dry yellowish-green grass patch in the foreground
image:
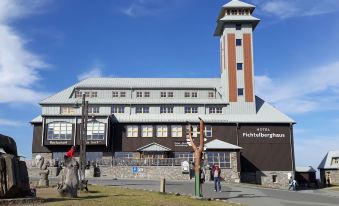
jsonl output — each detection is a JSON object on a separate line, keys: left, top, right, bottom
{"left": 28, "top": 185, "right": 239, "bottom": 206}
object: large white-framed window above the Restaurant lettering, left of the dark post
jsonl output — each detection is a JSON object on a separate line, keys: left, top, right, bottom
{"left": 47, "top": 122, "right": 72, "bottom": 140}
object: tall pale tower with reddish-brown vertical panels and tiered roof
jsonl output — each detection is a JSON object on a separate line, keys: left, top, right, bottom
{"left": 214, "top": 0, "right": 260, "bottom": 112}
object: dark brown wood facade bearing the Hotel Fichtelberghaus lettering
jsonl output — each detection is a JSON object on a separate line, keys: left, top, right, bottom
{"left": 32, "top": 122, "right": 294, "bottom": 172}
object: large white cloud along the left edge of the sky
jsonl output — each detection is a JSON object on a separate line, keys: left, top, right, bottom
{"left": 0, "top": 0, "right": 47, "bottom": 103}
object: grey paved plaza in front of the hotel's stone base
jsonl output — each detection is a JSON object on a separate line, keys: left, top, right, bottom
{"left": 89, "top": 178, "right": 339, "bottom": 206}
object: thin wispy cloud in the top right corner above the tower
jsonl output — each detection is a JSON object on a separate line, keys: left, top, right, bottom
{"left": 252, "top": 0, "right": 339, "bottom": 19}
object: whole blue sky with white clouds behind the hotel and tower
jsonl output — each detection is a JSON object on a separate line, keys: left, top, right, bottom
{"left": 0, "top": 0, "right": 339, "bottom": 167}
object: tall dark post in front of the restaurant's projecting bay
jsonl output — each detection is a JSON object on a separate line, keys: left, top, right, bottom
{"left": 75, "top": 90, "right": 88, "bottom": 189}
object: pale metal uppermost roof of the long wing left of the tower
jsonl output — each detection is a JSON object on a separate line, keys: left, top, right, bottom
{"left": 40, "top": 77, "right": 222, "bottom": 104}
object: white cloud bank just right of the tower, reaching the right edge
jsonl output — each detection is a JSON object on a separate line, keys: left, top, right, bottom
{"left": 255, "top": 61, "right": 339, "bottom": 114}
